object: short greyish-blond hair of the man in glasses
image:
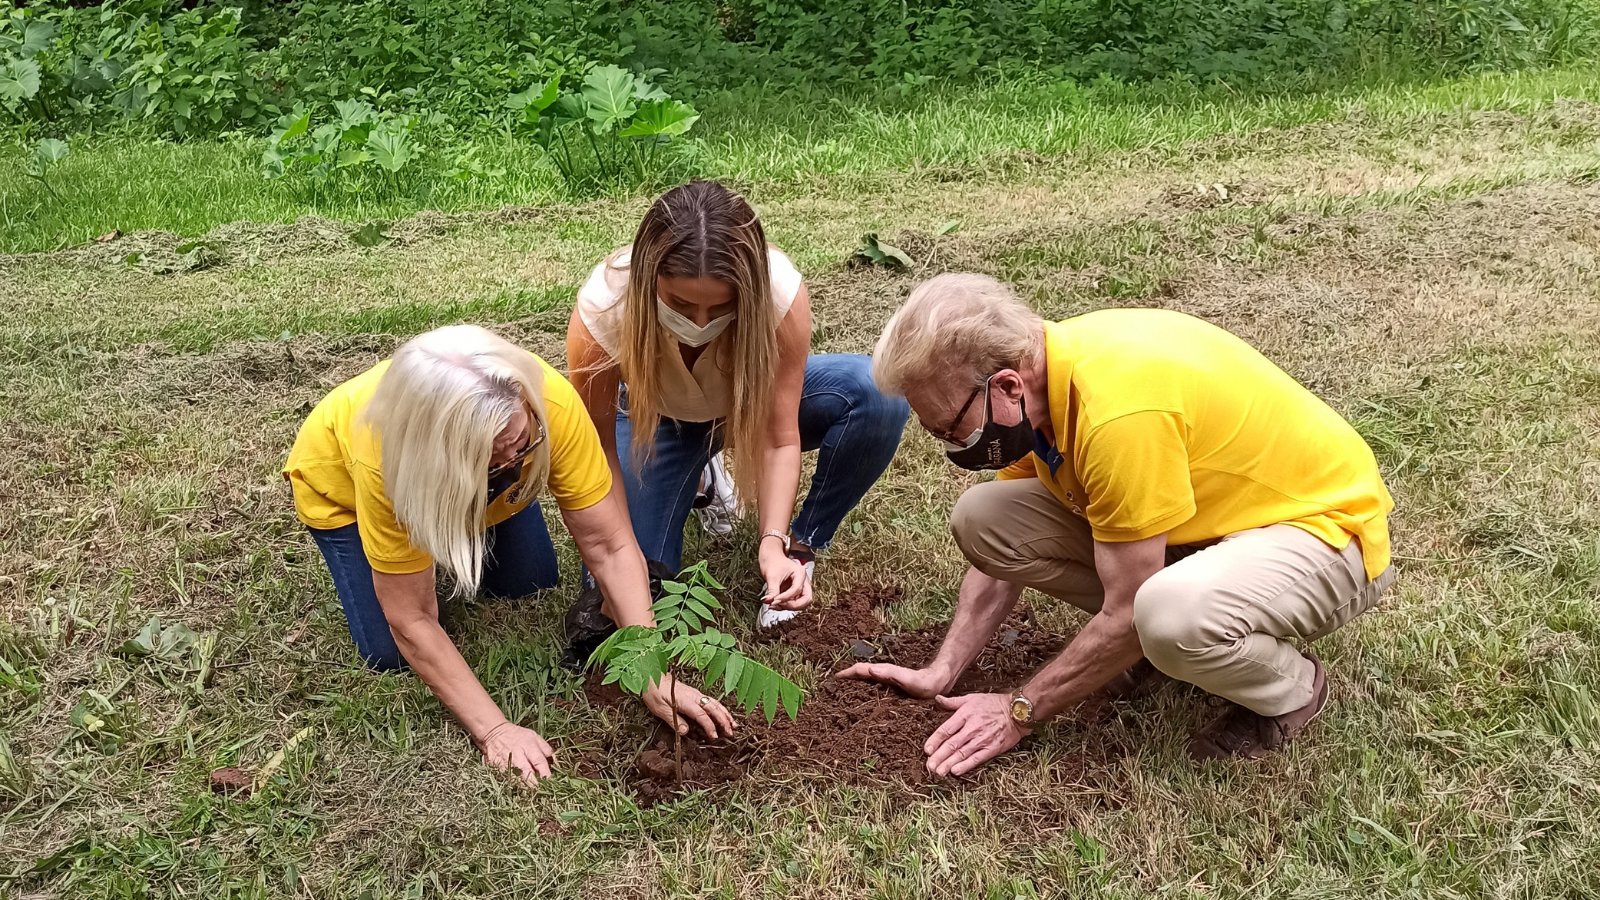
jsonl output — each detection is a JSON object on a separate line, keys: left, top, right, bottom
{"left": 872, "top": 272, "right": 1045, "bottom": 396}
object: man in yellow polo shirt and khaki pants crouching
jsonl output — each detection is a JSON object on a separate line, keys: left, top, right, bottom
{"left": 840, "top": 274, "right": 1394, "bottom": 775}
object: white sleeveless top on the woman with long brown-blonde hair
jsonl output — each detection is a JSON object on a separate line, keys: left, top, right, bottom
{"left": 578, "top": 247, "right": 802, "bottom": 421}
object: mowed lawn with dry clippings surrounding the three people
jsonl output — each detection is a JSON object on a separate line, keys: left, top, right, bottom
{"left": 0, "top": 75, "right": 1600, "bottom": 898}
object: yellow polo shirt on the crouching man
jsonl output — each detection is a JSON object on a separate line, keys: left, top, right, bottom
{"left": 1000, "top": 309, "right": 1394, "bottom": 578}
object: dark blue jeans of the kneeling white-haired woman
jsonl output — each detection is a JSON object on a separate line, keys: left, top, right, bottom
{"left": 307, "top": 503, "right": 560, "bottom": 671}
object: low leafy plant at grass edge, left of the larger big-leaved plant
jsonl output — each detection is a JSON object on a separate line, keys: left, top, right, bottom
{"left": 261, "top": 99, "right": 419, "bottom": 191}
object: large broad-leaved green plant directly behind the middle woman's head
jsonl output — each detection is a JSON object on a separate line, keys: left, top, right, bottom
{"left": 506, "top": 66, "right": 699, "bottom": 191}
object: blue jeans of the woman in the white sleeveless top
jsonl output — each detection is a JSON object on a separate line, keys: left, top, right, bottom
{"left": 616, "top": 354, "right": 910, "bottom": 572}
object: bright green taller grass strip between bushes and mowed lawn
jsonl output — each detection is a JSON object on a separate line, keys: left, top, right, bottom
{"left": 9, "top": 69, "right": 1600, "bottom": 251}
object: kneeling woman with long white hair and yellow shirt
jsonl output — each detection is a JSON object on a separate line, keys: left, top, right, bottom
{"left": 283, "top": 325, "right": 734, "bottom": 781}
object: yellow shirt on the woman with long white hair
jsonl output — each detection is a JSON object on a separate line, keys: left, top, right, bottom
{"left": 283, "top": 354, "right": 611, "bottom": 575}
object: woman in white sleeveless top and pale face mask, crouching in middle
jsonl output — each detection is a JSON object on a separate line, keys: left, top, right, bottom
{"left": 566, "top": 181, "right": 910, "bottom": 626}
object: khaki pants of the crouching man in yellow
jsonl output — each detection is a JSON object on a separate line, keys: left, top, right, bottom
{"left": 950, "top": 479, "right": 1395, "bottom": 716}
